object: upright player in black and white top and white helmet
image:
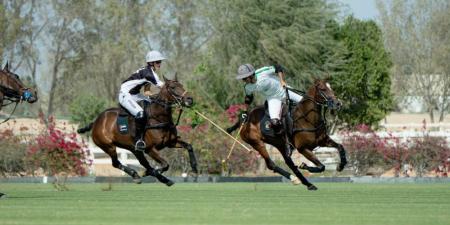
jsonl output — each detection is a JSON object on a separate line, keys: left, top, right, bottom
{"left": 119, "top": 51, "right": 166, "bottom": 151}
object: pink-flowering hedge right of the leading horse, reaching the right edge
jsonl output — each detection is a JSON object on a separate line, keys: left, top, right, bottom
{"left": 342, "top": 125, "right": 450, "bottom": 177}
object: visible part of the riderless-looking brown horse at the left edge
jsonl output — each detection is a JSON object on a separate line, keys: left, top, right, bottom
{"left": 0, "top": 63, "right": 38, "bottom": 114}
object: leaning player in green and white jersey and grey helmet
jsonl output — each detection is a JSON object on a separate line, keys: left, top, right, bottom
{"left": 236, "top": 64, "right": 303, "bottom": 135}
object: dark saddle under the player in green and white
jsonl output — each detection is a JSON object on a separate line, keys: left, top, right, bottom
{"left": 260, "top": 101, "right": 295, "bottom": 139}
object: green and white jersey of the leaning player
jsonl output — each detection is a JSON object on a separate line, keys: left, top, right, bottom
{"left": 245, "top": 66, "right": 286, "bottom": 100}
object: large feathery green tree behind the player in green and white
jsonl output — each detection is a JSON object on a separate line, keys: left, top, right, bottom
{"left": 196, "top": 0, "right": 341, "bottom": 109}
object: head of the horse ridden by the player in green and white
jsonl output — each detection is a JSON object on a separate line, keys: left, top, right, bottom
{"left": 308, "top": 79, "right": 342, "bottom": 110}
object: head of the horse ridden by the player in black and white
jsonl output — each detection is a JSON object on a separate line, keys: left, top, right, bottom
{"left": 160, "top": 76, "right": 194, "bottom": 107}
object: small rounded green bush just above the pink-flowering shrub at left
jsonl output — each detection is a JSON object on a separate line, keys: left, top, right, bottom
{"left": 69, "top": 95, "right": 107, "bottom": 125}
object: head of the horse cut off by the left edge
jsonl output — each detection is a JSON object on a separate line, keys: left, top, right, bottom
{"left": 0, "top": 63, "right": 38, "bottom": 103}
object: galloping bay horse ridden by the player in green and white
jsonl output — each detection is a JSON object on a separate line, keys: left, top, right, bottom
{"left": 227, "top": 79, "right": 347, "bottom": 190}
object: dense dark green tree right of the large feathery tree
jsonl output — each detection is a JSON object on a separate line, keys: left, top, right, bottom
{"left": 333, "top": 17, "right": 393, "bottom": 127}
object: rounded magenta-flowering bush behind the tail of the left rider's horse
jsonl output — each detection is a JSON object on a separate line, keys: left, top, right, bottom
{"left": 27, "top": 115, "right": 91, "bottom": 176}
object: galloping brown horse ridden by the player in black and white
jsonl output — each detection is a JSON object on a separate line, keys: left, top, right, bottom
{"left": 78, "top": 78, "right": 197, "bottom": 186}
